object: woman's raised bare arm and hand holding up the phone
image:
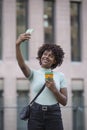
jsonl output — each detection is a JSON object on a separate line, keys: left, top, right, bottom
{"left": 16, "top": 33, "right": 31, "bottom": 77}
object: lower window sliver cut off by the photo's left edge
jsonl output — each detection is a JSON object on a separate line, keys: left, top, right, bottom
{"left": 0, "top": 79, "right": 4, "bottom": 130}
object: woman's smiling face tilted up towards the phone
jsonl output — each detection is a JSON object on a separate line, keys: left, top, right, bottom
{"left": 41, "top": 50, "right": 56, "bottom": 68}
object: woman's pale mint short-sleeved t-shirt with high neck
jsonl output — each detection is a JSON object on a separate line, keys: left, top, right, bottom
{"left": 28, "top": 68, "right": 66, "bottom": 105}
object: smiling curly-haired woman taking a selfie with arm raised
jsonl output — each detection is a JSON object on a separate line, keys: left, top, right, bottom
{"left": 16, "top": 33, "right": 67, "bottom": 130}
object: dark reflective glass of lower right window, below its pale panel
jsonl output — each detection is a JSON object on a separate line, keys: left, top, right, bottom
{"left": 72, "top": 90, "right": 84, "bottom": 130}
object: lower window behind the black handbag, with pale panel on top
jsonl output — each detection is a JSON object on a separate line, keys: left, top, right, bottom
{"left": 17, "top": 79, "right": 29, "bottom": 130}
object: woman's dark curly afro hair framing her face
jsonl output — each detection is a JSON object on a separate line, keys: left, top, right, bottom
{"left": 37, "top": 44, "right": 65, "bottom": 69}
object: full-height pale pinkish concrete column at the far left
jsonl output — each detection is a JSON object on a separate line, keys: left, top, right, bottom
{"left": 3, "top": 0, "right": 17, "bottom": 130}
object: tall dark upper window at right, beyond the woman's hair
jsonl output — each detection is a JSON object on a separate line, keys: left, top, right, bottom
{"left": 71, "top": 2, "right": 81, "bottom": 61}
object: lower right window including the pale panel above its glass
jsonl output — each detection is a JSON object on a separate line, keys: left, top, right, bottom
{"left": 72, "top": 79, "right": 85, "bottom": 130}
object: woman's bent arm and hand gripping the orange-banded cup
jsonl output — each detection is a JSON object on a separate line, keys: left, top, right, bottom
{"left": 46, "top": 80, "right": 67, "bottom": 106}
